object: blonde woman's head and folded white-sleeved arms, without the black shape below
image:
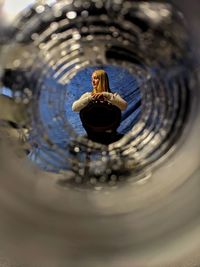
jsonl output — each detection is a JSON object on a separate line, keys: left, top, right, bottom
{"left": 72, "top": 70, "right": 128, "bottom": 112}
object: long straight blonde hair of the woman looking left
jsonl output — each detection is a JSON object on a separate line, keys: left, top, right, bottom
{"left": 92, "top": 70, "right": 111, "bottom": 93}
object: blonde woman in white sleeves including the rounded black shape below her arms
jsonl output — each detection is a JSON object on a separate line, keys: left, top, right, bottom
{"left": 72, "top": 70, "right": 128, "bottom": 144}
